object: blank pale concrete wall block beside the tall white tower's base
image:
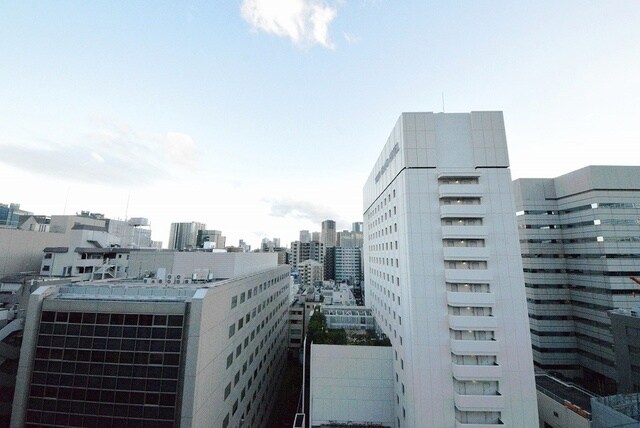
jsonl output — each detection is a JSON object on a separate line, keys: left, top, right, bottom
{"left": 310, "top": 345, "right": 395, "bottom": 427}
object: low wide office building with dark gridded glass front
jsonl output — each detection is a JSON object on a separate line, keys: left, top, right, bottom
{"left": 11, "top": 253, "right": 290, "bottom": 428}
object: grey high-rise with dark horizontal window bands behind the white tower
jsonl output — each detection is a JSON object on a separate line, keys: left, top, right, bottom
{"left": 513, "top": 166, "right": 640, "bottom": 393}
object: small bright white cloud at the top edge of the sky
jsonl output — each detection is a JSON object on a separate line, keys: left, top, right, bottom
{"left": 241, "top": 0, "right": 337, "bottom": 48}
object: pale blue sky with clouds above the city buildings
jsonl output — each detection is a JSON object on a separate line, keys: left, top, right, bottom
{"left": 0, "top": 0, "right": 640, "bottom": 248}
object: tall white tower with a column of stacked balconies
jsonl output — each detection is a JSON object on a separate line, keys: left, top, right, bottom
{"left": 364, "top": 112, "right": 538, "bottom": 428}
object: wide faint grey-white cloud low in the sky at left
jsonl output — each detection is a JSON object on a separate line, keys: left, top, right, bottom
{"left": 0, "top": 121, "right": 198, "bottom": 187}
